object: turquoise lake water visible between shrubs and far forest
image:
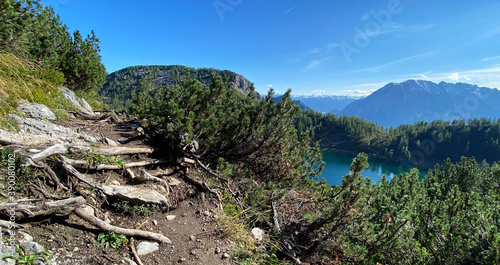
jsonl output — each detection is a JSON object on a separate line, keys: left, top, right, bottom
{"left": 319, "top": 152, "right": 426, "bottom": 185}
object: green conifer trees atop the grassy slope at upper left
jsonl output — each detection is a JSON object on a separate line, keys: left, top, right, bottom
{"left": 0, "top": 0, "right": 107, "bottom": 90}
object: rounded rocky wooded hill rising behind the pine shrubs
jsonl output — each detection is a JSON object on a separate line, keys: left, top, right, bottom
{"left": 99, "top": 65, "right": 263, "bottom": 111}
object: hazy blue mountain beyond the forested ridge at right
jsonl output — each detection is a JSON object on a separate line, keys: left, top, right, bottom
{"left": 340, "top": 80, "right": 500, "bottom": 127}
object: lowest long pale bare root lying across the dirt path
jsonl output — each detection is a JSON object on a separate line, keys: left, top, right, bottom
{"left": 75, "top": 205, "right": 172, "bottom": 244}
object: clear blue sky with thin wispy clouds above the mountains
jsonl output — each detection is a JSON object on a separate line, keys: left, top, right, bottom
{"left": 43, "top": 0, "right": 500, "bottom": 94}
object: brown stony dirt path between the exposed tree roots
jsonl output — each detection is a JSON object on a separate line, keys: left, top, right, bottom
{"left": 25, "top": 115, "right": 239, "bottom": 265}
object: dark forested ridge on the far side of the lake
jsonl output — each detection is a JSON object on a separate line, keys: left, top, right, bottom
{"left": 295, "top": 111, "right": 500, "bottom": 169}
